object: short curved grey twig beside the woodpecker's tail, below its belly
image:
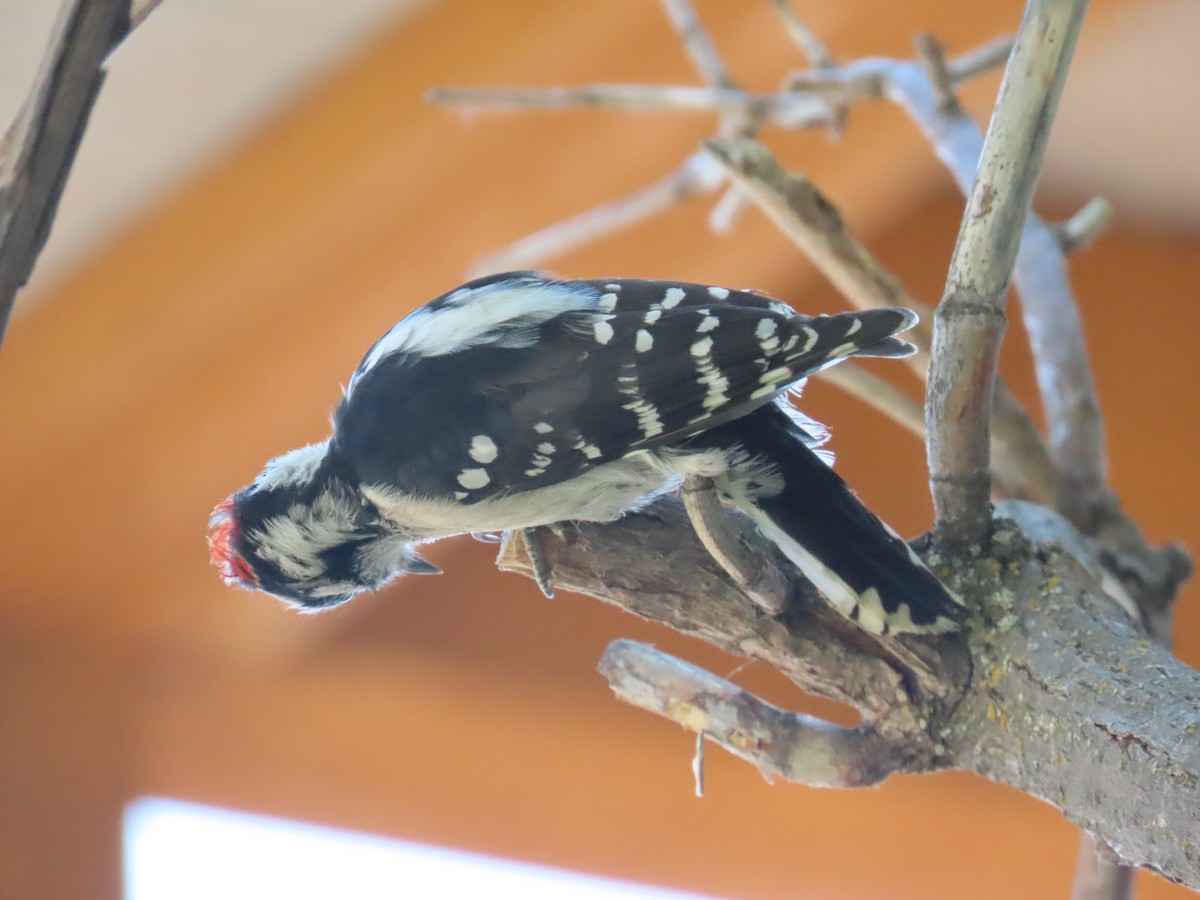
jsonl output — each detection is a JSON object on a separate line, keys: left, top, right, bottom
{"left": 680, "top": 475, "right": 790, "bottom": 616}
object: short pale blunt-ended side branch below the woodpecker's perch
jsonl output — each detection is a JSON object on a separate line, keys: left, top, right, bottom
{"left": 599, "top": 640, "right": 905, "bottom": 787}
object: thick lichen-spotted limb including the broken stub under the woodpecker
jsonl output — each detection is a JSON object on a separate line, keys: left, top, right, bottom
{"left": 500, "top": 498, "right": 1200, "bottom": 889}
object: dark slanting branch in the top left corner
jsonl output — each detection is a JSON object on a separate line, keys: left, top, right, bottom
{"left": 0, "top": 0, "right": 148, "bottom": 348}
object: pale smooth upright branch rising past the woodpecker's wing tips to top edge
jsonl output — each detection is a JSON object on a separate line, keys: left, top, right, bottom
{"left": 926, "top": 0, "right": 1087, "bottom": 544}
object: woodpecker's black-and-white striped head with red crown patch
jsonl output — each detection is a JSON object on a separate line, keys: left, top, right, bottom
{"left": 209, "top": 442, "right": 439, "bottom": 612}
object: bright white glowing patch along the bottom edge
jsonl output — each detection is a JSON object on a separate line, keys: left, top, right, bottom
{"left": 125, "top": 797, "right": 715, "bottom": 900}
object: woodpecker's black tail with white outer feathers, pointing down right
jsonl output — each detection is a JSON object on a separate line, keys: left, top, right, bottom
{"left": 700, "top": 403, "right": 965, "bottom": 634}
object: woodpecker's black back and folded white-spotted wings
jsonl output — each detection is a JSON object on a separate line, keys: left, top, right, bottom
{"left": 330, "top": 272, "right": 916, "bottom": 504}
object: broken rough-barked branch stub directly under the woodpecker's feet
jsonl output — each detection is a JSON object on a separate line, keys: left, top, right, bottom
{"left": 498, "top": 497, "right": 968, "bottom": 734}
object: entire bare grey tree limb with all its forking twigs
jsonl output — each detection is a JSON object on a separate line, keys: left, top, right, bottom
{"left": 443, "top": 0, "right": 1200, "bottom": 895}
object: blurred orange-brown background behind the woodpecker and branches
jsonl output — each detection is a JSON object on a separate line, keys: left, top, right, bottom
{"left": 0, "top": 0, "right": 1200, "bottom": 899}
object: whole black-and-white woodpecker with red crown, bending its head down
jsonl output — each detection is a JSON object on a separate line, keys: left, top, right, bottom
{"left": 210, "top": 272, "right": 961, "bottom": 632}
